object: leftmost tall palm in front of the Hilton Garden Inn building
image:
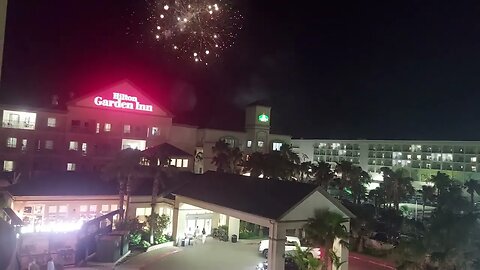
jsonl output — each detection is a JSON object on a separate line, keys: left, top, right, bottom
{"left": 103, "top": 148, "right": 143, "bottom": 220}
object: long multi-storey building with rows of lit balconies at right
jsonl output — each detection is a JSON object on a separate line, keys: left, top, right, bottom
{"left": 292, "top": 139, "right": 480, "bottom": 184}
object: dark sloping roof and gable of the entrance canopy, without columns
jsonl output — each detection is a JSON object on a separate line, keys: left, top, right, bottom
{"left": 173, "top": 172, "right": 354, "bottom": 221}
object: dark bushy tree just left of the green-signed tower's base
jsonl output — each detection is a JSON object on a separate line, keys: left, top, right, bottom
{"left": 212, "top": 140, "right": 243, "bottom": 173}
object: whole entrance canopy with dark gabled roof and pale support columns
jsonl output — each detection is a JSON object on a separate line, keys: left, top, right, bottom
{"left": 172, "top": 172, "right": 354, "bottom": 270}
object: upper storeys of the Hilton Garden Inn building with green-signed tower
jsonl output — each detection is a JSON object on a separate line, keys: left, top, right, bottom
{"left": 0, "top": 81, "right": 290, "bottom": 178}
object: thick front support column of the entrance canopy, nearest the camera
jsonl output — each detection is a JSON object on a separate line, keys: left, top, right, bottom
{"left": 268, "top": 222, "right": 287, "bottom": 270}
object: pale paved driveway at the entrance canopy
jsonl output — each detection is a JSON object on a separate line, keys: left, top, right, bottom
{"left": 115, "top": 238, "right": 393, "bottom": 270}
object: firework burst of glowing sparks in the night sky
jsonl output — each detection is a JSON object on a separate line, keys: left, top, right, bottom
{"left": 131, "top": 0, "right": 242, "bottom": 65}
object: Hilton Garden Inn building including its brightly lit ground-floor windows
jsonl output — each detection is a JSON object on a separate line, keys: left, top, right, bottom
{"left": 0, "top": 81, "right": 290, "bottom": 229}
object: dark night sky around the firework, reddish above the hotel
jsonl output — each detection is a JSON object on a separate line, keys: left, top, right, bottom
{"left": 0, "top": 0, "right": 480, "bottom": 140}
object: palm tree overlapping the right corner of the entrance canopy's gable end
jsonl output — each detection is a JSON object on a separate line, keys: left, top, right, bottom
{"left": 305, "top": 209, "right": 349, "bottom": 269}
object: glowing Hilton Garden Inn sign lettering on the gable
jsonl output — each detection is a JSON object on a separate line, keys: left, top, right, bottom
{"left": 93, "top": 92, "right": 153, "bottom": 112}
